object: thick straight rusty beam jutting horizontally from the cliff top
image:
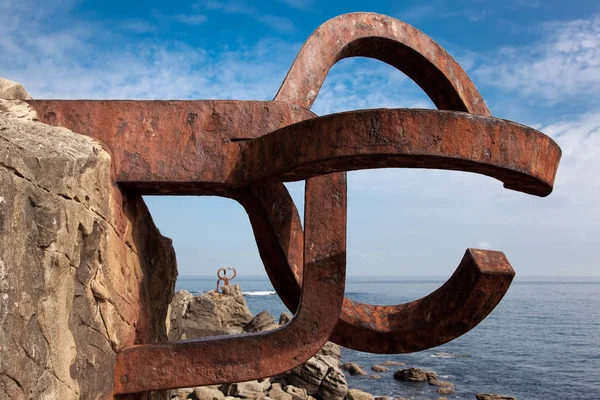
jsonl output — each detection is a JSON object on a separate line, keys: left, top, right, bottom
{"left": 27, "top": 100, "right": 315, "bottom": 195}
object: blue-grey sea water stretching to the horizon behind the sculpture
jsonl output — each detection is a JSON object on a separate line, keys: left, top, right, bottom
{"left": 176, "top": 277, "right": 600, "bottom": 400}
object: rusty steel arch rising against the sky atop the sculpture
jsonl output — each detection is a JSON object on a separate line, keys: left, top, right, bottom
{"left": 274, "top": 12, "right": 491, "bottom": 115}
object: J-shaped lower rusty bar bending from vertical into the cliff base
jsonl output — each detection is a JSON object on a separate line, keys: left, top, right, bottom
{"left": 115, "top": 174, "right": 346, "bottom": 394}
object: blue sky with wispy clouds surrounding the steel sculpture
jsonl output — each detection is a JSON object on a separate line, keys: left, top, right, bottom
{"left": 0, "top": 0, "right": 600, "bottom": 277}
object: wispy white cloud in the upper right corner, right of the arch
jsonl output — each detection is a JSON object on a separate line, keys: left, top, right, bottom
{"left": 475, "top": 15, "right": 600, "bottom": 104}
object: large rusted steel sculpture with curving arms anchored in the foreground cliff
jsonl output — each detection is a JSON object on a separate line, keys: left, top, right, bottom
{"left": 21, "top": 13, "right": 561, "bottom": 394}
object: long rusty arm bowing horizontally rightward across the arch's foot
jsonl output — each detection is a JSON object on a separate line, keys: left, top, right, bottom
{"left": 237, "top": 109, "right": 560, "bottom": 196}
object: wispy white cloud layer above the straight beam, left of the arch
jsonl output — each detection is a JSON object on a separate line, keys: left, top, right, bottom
{"left": 0, "top": 1, "right": 299, "bottom": 100}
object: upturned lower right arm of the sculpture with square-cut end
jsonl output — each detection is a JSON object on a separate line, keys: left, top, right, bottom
{"left": 331, "top": 249, "right": 515, "bottom": 354}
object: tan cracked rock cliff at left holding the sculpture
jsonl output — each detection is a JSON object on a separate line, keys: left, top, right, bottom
{"left": 0, "top": 81, "right": 177, "bottom": 399}
